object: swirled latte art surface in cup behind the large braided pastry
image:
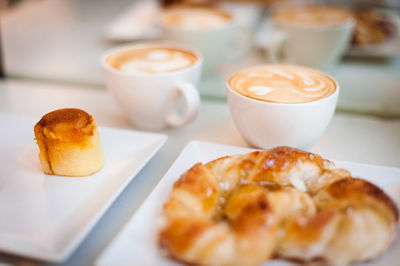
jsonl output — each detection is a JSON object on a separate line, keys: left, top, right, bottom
{"left": 228, "top": 65, "right": 337, "bottom": 103}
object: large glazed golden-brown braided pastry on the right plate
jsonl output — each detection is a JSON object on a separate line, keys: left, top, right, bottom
{"left": 159, "top": 147, "right": 398, "bottom": 265}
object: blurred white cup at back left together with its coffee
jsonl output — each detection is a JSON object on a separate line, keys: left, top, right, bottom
{"left": 161, "top": 7, "right": 244, "bottom": 74}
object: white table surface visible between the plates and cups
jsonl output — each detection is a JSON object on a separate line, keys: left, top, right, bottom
{"left": 0, "top": 80, "right": 400, "bottom": 265}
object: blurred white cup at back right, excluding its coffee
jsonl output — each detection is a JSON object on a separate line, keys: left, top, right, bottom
{"left": 265, "top": 6, "right": 355, "bottom": 69}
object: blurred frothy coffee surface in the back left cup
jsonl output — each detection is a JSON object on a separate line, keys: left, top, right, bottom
{"left": 162, "top": 8, "right": 232, "bottom": 30}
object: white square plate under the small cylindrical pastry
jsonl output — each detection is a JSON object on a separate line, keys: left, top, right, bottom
{"left": 0, "top": 113, "right": 167, "bottom": 262}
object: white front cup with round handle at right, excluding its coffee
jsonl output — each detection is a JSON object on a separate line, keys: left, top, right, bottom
{"left": 101, "top": 43, "right": 203, "bottom": 130}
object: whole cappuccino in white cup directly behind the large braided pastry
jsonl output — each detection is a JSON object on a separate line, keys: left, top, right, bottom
{"left": 227, "top": 64, "right": 339, "bottom": 149}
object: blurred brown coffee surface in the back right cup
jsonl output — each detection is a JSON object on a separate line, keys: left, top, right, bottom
{"left": 272, "top": 6, "right": 351, "bottom": 26}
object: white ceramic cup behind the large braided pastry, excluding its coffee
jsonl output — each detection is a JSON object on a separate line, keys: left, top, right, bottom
{"left": 227, "top": 64, "right": 339, "bottom": 150}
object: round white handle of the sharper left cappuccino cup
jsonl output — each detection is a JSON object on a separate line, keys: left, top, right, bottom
{"left": 166, "top": 82, "right": 200, "bottom": 127}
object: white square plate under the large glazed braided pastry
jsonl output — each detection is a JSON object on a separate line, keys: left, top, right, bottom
{"left": 96, "top": 141, "right": 400, "bottom": 266}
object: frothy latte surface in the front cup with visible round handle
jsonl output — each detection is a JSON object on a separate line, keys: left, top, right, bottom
{"left": 106, "top": 47, "right": 198, "bottom": 74}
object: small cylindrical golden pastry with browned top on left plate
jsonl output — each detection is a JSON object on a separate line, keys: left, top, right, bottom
{"left": 34, "top": 108, "right": 104, "bottom": 176}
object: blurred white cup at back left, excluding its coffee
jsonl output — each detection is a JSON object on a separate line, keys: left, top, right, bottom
{"left": 160, "top": 8, "right": 242, "bottom": 74}
